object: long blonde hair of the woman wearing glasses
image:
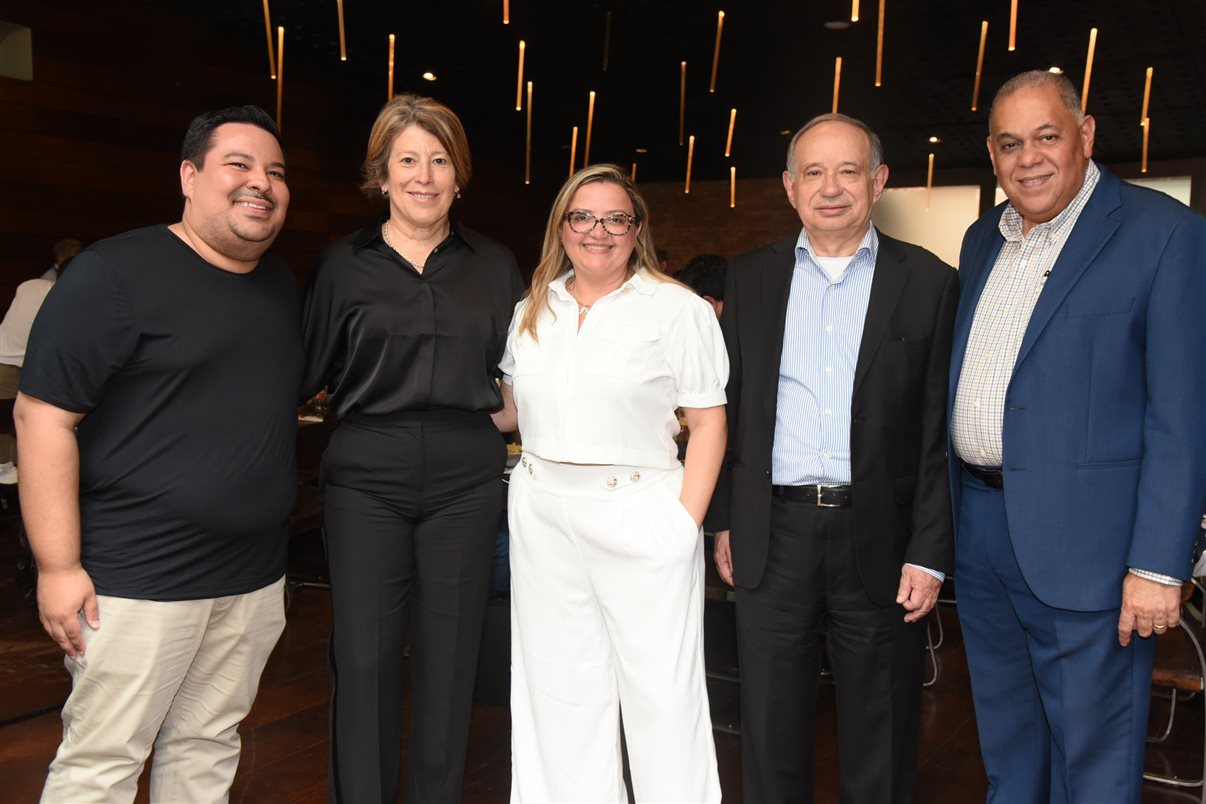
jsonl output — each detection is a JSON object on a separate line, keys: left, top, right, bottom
{"left": 519, "top": 164, "right": 674, "bottom": 340}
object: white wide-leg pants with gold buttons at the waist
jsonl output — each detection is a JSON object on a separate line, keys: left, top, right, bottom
{"left": 508, "top": 454, "right": 720, "bottom": 803}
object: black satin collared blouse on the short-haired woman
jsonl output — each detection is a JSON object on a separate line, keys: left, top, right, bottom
{"left": 302, "top": 217, "right": 523, "bottom": 417}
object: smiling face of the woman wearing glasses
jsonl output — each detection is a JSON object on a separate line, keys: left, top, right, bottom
{"left": 561, "top": 181, "right": 640, "bottom": 281}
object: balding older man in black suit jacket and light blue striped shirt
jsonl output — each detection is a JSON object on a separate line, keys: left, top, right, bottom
{"left": 707, "top": 115, "right": 958, "bottom": 804}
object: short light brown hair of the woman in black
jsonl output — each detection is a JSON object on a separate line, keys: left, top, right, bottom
{"left": 361, "top": 94, "right": 473, "bottom": 200}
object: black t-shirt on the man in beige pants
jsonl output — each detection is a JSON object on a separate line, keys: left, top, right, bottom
{"left": 21, "top": 227, "right": 303, "bottom": 600}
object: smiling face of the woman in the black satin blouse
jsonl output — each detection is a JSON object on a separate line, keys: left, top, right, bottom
{"left": 381, "top": 125, "right": 461, "bottom": 234}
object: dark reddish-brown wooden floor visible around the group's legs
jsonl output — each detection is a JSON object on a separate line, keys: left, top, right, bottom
{"left": 0, "top": 534, "right": 1202, "bottom": 804}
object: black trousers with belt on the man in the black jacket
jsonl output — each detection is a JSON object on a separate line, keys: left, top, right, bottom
{"left": 737, "top": 499, "right": 925, "bottom": 804}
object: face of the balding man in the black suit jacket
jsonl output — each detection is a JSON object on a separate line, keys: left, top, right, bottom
{"left": 783, "top": 121, "right": 888, "bottom": 257}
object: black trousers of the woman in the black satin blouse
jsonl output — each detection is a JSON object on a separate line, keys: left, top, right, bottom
{"left": 323, "top": 411, "right": 507, "bottom": 804}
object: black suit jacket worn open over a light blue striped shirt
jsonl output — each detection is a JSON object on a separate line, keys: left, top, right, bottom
{"left": 707, "top": 227, "right": 959, "bottom": 605}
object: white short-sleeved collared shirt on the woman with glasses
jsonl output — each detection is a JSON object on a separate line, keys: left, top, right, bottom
{"left": 499, "top": 271, "right": 728, "bottom": 469}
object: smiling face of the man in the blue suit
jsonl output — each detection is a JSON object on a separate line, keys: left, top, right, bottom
{"left": 988, "top": 84, "right": 1096, "bottom": 234}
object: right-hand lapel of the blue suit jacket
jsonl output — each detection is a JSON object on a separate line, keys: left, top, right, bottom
{"left": 1013, "top": 169, "right": 1120, "bottom": 371}
